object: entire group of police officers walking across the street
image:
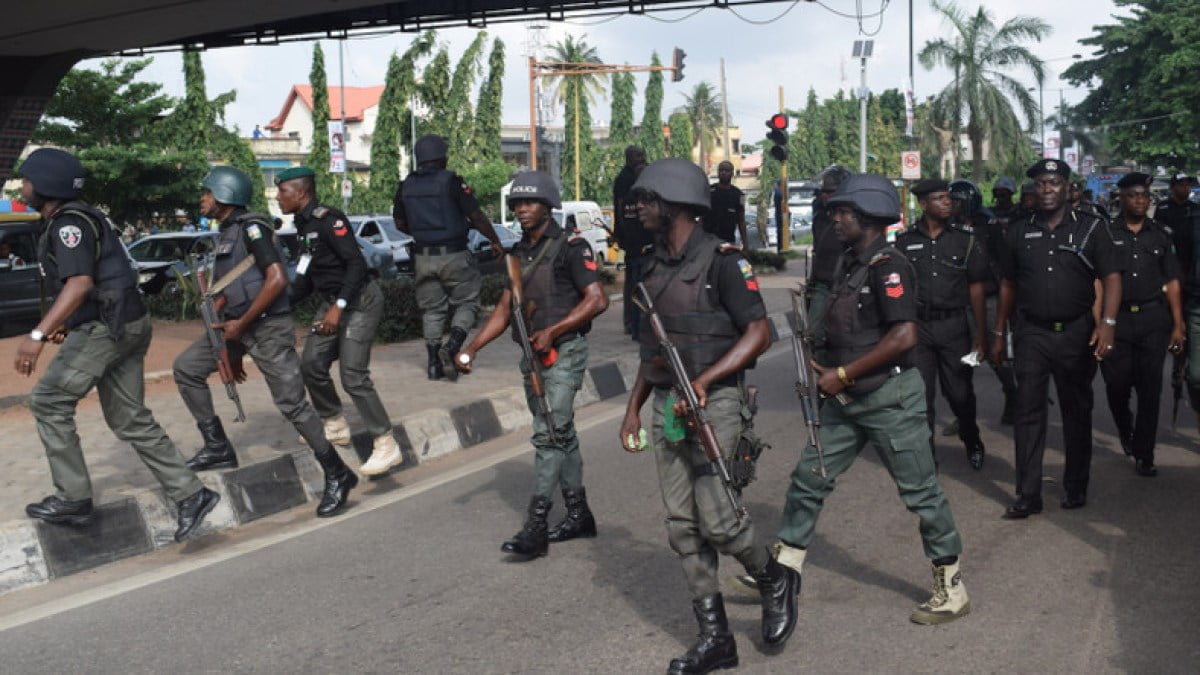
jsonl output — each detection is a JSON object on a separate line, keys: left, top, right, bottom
{"left": 7, "top": 136, "right": 1200, "bottom": 674}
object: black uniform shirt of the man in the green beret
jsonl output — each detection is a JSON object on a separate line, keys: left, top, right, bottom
{"left": 292, "top": 199, "right": 367, "bottom": 305}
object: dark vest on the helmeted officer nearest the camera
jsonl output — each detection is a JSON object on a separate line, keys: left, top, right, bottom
{"left": 640, "top": 233, "right": 754, "bottom": 387}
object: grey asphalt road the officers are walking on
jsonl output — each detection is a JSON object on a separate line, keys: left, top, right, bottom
{"left": 0, "top": 344, "right": 1200, "bottom": 673}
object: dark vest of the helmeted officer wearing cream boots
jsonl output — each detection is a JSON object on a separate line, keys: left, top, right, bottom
{"left": 824, "top": 246, "right": 912, "bottom": 396}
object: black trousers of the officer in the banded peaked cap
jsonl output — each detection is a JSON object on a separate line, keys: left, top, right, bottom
{"left": 1013, "top": 312, "right": 1096, "bottom": 498}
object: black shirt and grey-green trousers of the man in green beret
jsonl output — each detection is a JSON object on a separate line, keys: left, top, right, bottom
{"left": 288, "top": 194, "right": 391, "bottom": 451}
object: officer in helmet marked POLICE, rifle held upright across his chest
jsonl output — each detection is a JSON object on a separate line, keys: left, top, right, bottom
{"left": 456, "top": 172, "right": 608, "bottom": 560}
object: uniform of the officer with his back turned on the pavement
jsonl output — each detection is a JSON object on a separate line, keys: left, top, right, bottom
{"left": 392, "top": 139, "right": 481, "bottom": 357}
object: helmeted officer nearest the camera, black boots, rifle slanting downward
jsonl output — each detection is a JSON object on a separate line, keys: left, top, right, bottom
{"left": 620, "top": 159, "right": 800, "bottom": 673}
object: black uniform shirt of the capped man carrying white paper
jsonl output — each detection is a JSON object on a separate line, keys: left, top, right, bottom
{"left": 895, "top": 219, "right": 991, "bottom": 310}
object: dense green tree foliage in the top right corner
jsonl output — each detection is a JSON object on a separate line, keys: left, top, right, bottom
{"left": 1063, "top": 0, "right": 1200, "bottom": 172}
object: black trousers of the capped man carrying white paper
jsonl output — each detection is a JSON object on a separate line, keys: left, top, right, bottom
{"left": 913, "top": 310, "right": 979, "bottom": 451}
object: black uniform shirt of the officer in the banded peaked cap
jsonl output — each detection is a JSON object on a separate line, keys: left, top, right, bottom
{"left": 1001, "top": 210, "right": 1129, "bottom": 321}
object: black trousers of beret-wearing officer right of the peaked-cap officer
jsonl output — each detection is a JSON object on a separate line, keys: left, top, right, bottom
{"left": 1100, "top": 300, "right": 1171, "bottom": 464}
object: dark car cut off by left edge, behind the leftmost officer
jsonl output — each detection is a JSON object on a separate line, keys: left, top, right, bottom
{"left": 0, "top": 211, "right": 46, "bottom": 335}
